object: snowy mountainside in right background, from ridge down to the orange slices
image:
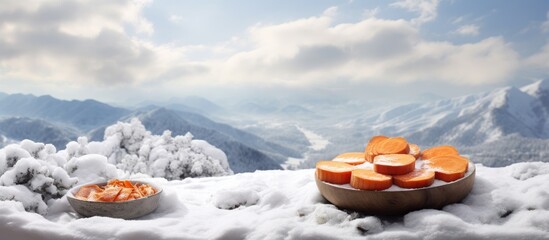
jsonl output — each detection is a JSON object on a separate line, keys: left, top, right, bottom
{"left": 288, "top": 80, "right": 549, "bottom": 168}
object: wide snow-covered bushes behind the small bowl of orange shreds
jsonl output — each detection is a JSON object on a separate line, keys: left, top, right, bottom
{"left": 69, "top": 118, "right": 233, "bottom": 180}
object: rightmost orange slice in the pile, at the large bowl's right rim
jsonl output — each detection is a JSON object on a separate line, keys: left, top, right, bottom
{"left": 425, "top": 155, "right": 469, "bottom": 182}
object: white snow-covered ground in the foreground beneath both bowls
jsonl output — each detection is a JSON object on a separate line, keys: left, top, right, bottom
{"left": 0, "top": 162, "right": 549, "bottom": 240}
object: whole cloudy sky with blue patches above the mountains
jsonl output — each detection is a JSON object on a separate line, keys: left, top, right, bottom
{"left": 0, "top": 0, "right": 549, "bottom": 104}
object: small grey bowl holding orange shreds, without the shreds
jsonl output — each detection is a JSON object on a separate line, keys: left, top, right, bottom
{"left": 67, "top": 180, "right": 162, "bottom": 219}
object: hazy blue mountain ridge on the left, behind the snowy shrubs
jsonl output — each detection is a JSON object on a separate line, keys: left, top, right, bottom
{"left": 0, "top": 94, "right": 300, "bottom": 173}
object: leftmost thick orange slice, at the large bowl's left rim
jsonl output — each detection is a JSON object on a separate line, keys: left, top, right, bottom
{"left": 316, "top": 161, "right": 353, "bottom": 184}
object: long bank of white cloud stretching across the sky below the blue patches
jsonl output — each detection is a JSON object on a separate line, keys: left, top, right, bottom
{"left": 0, "top": 0, "right": 520, "bottom": 100}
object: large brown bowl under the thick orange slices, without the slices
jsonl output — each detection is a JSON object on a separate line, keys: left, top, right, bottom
{"left": 315, "top": 162, "right": 476, "bottom": 216}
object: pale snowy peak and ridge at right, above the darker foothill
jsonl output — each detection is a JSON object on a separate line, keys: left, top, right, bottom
{"left": 348, "top": 81, "right": 549, "bottom": 146}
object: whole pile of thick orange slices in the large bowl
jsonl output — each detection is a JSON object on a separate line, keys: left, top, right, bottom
{"left": 316, "top": 136, "right": 469, "bottom": 191}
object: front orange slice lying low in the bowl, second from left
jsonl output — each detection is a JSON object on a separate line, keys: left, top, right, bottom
{"left": 351, "top": 169, "right": 393, "bottom": 191}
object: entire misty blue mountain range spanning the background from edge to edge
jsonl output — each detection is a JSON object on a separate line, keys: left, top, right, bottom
{"left": 0, "top": 80, "right": 549, "bottom": 169}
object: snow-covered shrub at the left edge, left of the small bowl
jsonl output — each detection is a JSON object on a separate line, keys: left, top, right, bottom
{"left": 0, "top": 140, "right": 78, "bottom": 214}
